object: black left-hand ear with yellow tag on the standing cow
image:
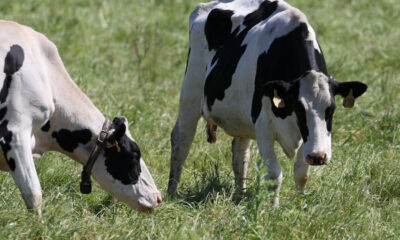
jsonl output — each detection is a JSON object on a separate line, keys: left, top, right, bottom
{"left": 263, "top": 81, "right": 290, "bottom": 108}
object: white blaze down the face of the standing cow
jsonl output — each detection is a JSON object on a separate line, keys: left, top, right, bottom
{"left": 299, "top": 70, "right": 332, "bottom": 161}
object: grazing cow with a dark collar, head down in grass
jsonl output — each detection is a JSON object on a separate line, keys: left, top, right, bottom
{"left": 0, "top": 21, "right": 161, "bottom": 215}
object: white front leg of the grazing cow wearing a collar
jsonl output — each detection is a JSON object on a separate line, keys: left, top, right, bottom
{"left": 1, "top": 130, "right": 42, "bottom": 217}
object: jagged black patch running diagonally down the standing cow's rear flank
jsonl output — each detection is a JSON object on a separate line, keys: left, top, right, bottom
{"left": 204, "top": 1, "right": 278, "bottom": 111}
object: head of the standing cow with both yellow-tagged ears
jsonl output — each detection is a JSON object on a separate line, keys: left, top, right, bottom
{"left": 264, "top": 70, "right": 367, "bottom": 165}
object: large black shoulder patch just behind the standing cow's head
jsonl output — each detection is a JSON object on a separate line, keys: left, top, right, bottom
{"left": 251, "top": 23, "right": 327, "bottom": 123}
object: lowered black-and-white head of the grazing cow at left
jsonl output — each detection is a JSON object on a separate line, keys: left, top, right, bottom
{"left": 92, "top": 117, "right": 161, "bottom": 211}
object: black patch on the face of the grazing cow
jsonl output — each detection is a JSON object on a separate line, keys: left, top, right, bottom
{"left": 104, "top": 135, "right": 141, "bottom": 185}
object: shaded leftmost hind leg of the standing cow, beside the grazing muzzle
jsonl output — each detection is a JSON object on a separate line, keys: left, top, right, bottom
{"left": 167, "top": 101, "right": 200, "bottom": 194}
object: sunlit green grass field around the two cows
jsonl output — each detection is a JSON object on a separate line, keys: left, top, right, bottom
{"left": 0, "top": 0, "right": 400, "bottom": 239}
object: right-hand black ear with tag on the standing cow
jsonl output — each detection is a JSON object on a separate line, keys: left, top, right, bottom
{"left": 334, "top": 81, "right": 368, "bottom": 108}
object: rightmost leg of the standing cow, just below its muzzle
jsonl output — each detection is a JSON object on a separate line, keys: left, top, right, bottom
{"left": 293, "top": 144, "right": 310, "bottom": 192}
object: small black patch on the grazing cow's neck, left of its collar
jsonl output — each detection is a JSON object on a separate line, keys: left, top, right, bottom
{"left": 51, "top": 129, "right": 92, "bottom": 152}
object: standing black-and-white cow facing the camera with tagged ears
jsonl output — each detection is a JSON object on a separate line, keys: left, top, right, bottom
{"left": 168, "top": 0, "right": 367, "bottom": 204}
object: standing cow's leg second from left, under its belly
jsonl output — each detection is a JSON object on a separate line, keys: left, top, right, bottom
{"left": 232, "top": 137, "right": 250, "bottom": 193}
